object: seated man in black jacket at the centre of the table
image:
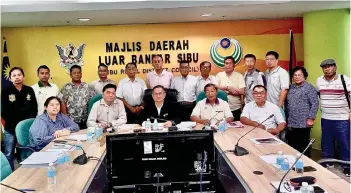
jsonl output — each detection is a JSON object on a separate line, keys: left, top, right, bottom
{"left": 142, "top": 85, "right": 181, "bottom": 127}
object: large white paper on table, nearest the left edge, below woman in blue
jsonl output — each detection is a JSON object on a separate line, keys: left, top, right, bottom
{"left": 20, "top": 151, "right": 61, "bottom": 165}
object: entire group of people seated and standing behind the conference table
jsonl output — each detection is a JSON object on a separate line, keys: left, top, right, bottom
{"left": 1, "top": 51, "right": 350, "bottom": 175}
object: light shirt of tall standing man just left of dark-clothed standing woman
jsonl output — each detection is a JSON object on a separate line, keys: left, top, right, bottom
{"left": 265, "top": 66, "right": 290, "bottom": 105}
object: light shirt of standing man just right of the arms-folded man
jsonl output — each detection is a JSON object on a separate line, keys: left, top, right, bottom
{"left": 244, "top": 69, "right": 267, "bottom": 104}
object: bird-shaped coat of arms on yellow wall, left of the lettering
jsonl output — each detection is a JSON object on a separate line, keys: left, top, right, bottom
{"left": 56, "top": 43, "right": 85, "bottom": 73}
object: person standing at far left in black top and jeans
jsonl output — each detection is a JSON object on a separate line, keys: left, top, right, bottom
{"left": 1, "top": 67, "right": 38, "bottom": 170}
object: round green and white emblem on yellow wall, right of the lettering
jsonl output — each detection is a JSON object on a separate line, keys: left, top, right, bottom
{"left": 210, "top": 37, "right": 243, "bottom": 68}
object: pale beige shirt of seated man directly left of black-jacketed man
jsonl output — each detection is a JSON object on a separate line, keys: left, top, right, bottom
{"left": 87, "top": 99, "right": 127, "bottom": 129}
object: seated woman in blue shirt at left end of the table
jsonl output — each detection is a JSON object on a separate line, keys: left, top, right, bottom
{"left": 29, "top": 97, "right": 79, "bottom": 151}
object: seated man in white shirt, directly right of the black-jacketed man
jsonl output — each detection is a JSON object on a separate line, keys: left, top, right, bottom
{"left": 190, "top": 83, "right": 234, "bottom": 125}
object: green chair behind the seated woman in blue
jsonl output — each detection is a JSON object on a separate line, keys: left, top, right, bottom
{"left": 15, "top": 118, "right": 35, "bottom": 160}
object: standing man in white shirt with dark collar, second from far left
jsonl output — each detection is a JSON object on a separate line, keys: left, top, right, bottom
{"left": 32, "top": 65, "right": 59, "bottom": 115}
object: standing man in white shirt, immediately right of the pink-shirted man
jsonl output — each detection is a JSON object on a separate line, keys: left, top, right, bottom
{"left": 171, "top": 61, "right": 197, "bottom": 121}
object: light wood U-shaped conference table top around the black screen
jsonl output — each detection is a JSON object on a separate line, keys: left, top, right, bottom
{"left": 1, "top": 125, "right": 350, "bottom": 193}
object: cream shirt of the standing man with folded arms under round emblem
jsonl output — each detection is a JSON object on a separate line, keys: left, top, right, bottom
{"left": 217, "top": 72, "right": 245, "bottom": 111}
